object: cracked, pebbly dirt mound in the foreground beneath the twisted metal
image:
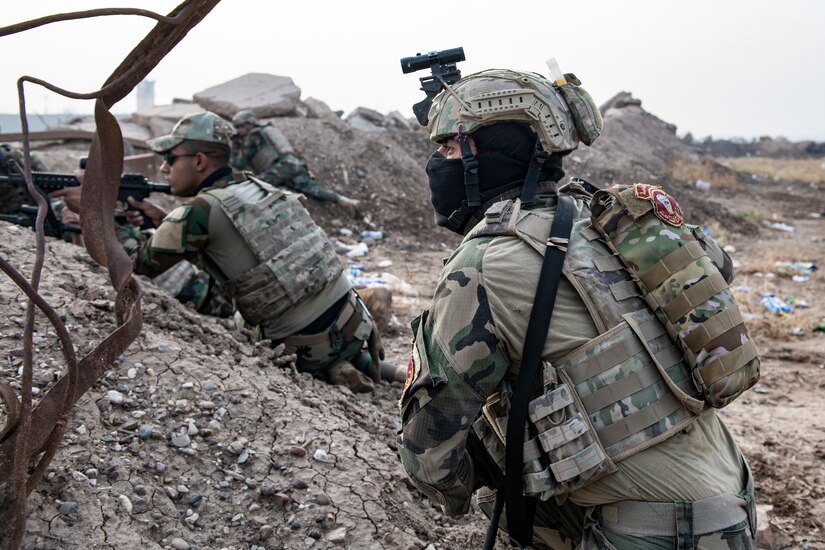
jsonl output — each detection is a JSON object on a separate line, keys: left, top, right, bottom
{"left": 0, "top": 223, "right": 486, "bottom": 549}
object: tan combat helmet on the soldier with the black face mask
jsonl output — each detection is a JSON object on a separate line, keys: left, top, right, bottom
{"left": 427, "top": 69, "right": 601, "bottom": 153}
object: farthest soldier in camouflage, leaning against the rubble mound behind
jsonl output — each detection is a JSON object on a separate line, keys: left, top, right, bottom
{"left": 231, "top": 110, "right": 360, "bottom": 215}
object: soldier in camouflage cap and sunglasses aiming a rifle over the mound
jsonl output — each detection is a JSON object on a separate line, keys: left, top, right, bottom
{"left": 113, "top": 112, "right": 402, "bottom": 391}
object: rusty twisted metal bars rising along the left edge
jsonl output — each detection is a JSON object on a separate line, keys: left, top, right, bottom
{"left": 0, "top": 0, "right": 220, "bottom": 548}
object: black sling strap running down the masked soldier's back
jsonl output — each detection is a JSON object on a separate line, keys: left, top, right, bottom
{"left": 504, "top": 195, "right": 573, "bottom": 548}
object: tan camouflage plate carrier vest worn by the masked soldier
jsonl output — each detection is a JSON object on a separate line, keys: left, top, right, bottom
{"left": 466, "top": 195, "right": 705, "bottom": 500}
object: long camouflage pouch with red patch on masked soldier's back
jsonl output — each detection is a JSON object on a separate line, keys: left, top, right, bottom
{"left": 592, "top": 184, "right": 760, "bottom": 407}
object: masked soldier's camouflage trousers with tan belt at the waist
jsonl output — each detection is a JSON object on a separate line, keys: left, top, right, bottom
{"left": 579, "top": 465, "right": 756, "bottom": 550}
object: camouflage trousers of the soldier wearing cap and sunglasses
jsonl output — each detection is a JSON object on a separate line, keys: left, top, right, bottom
{"left": 281, "top": 290, "right": 373, "bottom": 375}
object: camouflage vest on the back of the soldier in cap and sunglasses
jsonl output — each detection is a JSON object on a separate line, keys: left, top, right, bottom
{"left": 208, "top": 180, "right": 343, "bottom": 333}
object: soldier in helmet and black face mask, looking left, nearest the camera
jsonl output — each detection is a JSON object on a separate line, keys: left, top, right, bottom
{"left": 399, "top": 70, "right": 758, "bottom": 550}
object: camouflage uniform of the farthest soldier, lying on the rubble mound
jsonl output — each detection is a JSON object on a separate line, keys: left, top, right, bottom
{"left": 231, "top": 123, "right": 341, "bottom": 202}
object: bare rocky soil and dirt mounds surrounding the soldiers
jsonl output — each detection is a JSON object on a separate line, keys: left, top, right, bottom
{"left": 0, "top": 97, "right": 825, "bottom": 550}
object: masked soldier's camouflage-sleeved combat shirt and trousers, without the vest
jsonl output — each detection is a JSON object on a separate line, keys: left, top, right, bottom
{"left": 399, "top": 192, "right": 752, "bottom": 549}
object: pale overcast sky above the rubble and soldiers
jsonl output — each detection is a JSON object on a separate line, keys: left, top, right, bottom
{"left": 0, "top": 0, "right": 825, "bottom": 141}
